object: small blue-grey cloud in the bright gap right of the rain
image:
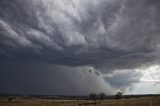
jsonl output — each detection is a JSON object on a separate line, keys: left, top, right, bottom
{"left": 104, "top": 70, "right": 142, "bottom": 90}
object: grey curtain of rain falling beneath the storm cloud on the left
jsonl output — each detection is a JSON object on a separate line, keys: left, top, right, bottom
{"left": 0, "top": 61, "right": 113, "bottom": 95}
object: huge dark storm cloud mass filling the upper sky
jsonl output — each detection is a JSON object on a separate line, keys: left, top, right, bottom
{"left": 0, "top": 0, "right": 160, "bottom": 69}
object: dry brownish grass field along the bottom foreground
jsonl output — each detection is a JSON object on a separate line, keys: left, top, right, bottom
{"left": 0, "top": 97, "right": 160, "bottom": 106}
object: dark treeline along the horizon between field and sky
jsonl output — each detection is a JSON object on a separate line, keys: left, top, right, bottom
{"left": 0, "top": 92, "right": 160, "bottom": 101}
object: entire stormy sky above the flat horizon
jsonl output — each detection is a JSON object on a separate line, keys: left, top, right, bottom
{"left": 0, "top": 0, "right": 160, "bottom": 95}
